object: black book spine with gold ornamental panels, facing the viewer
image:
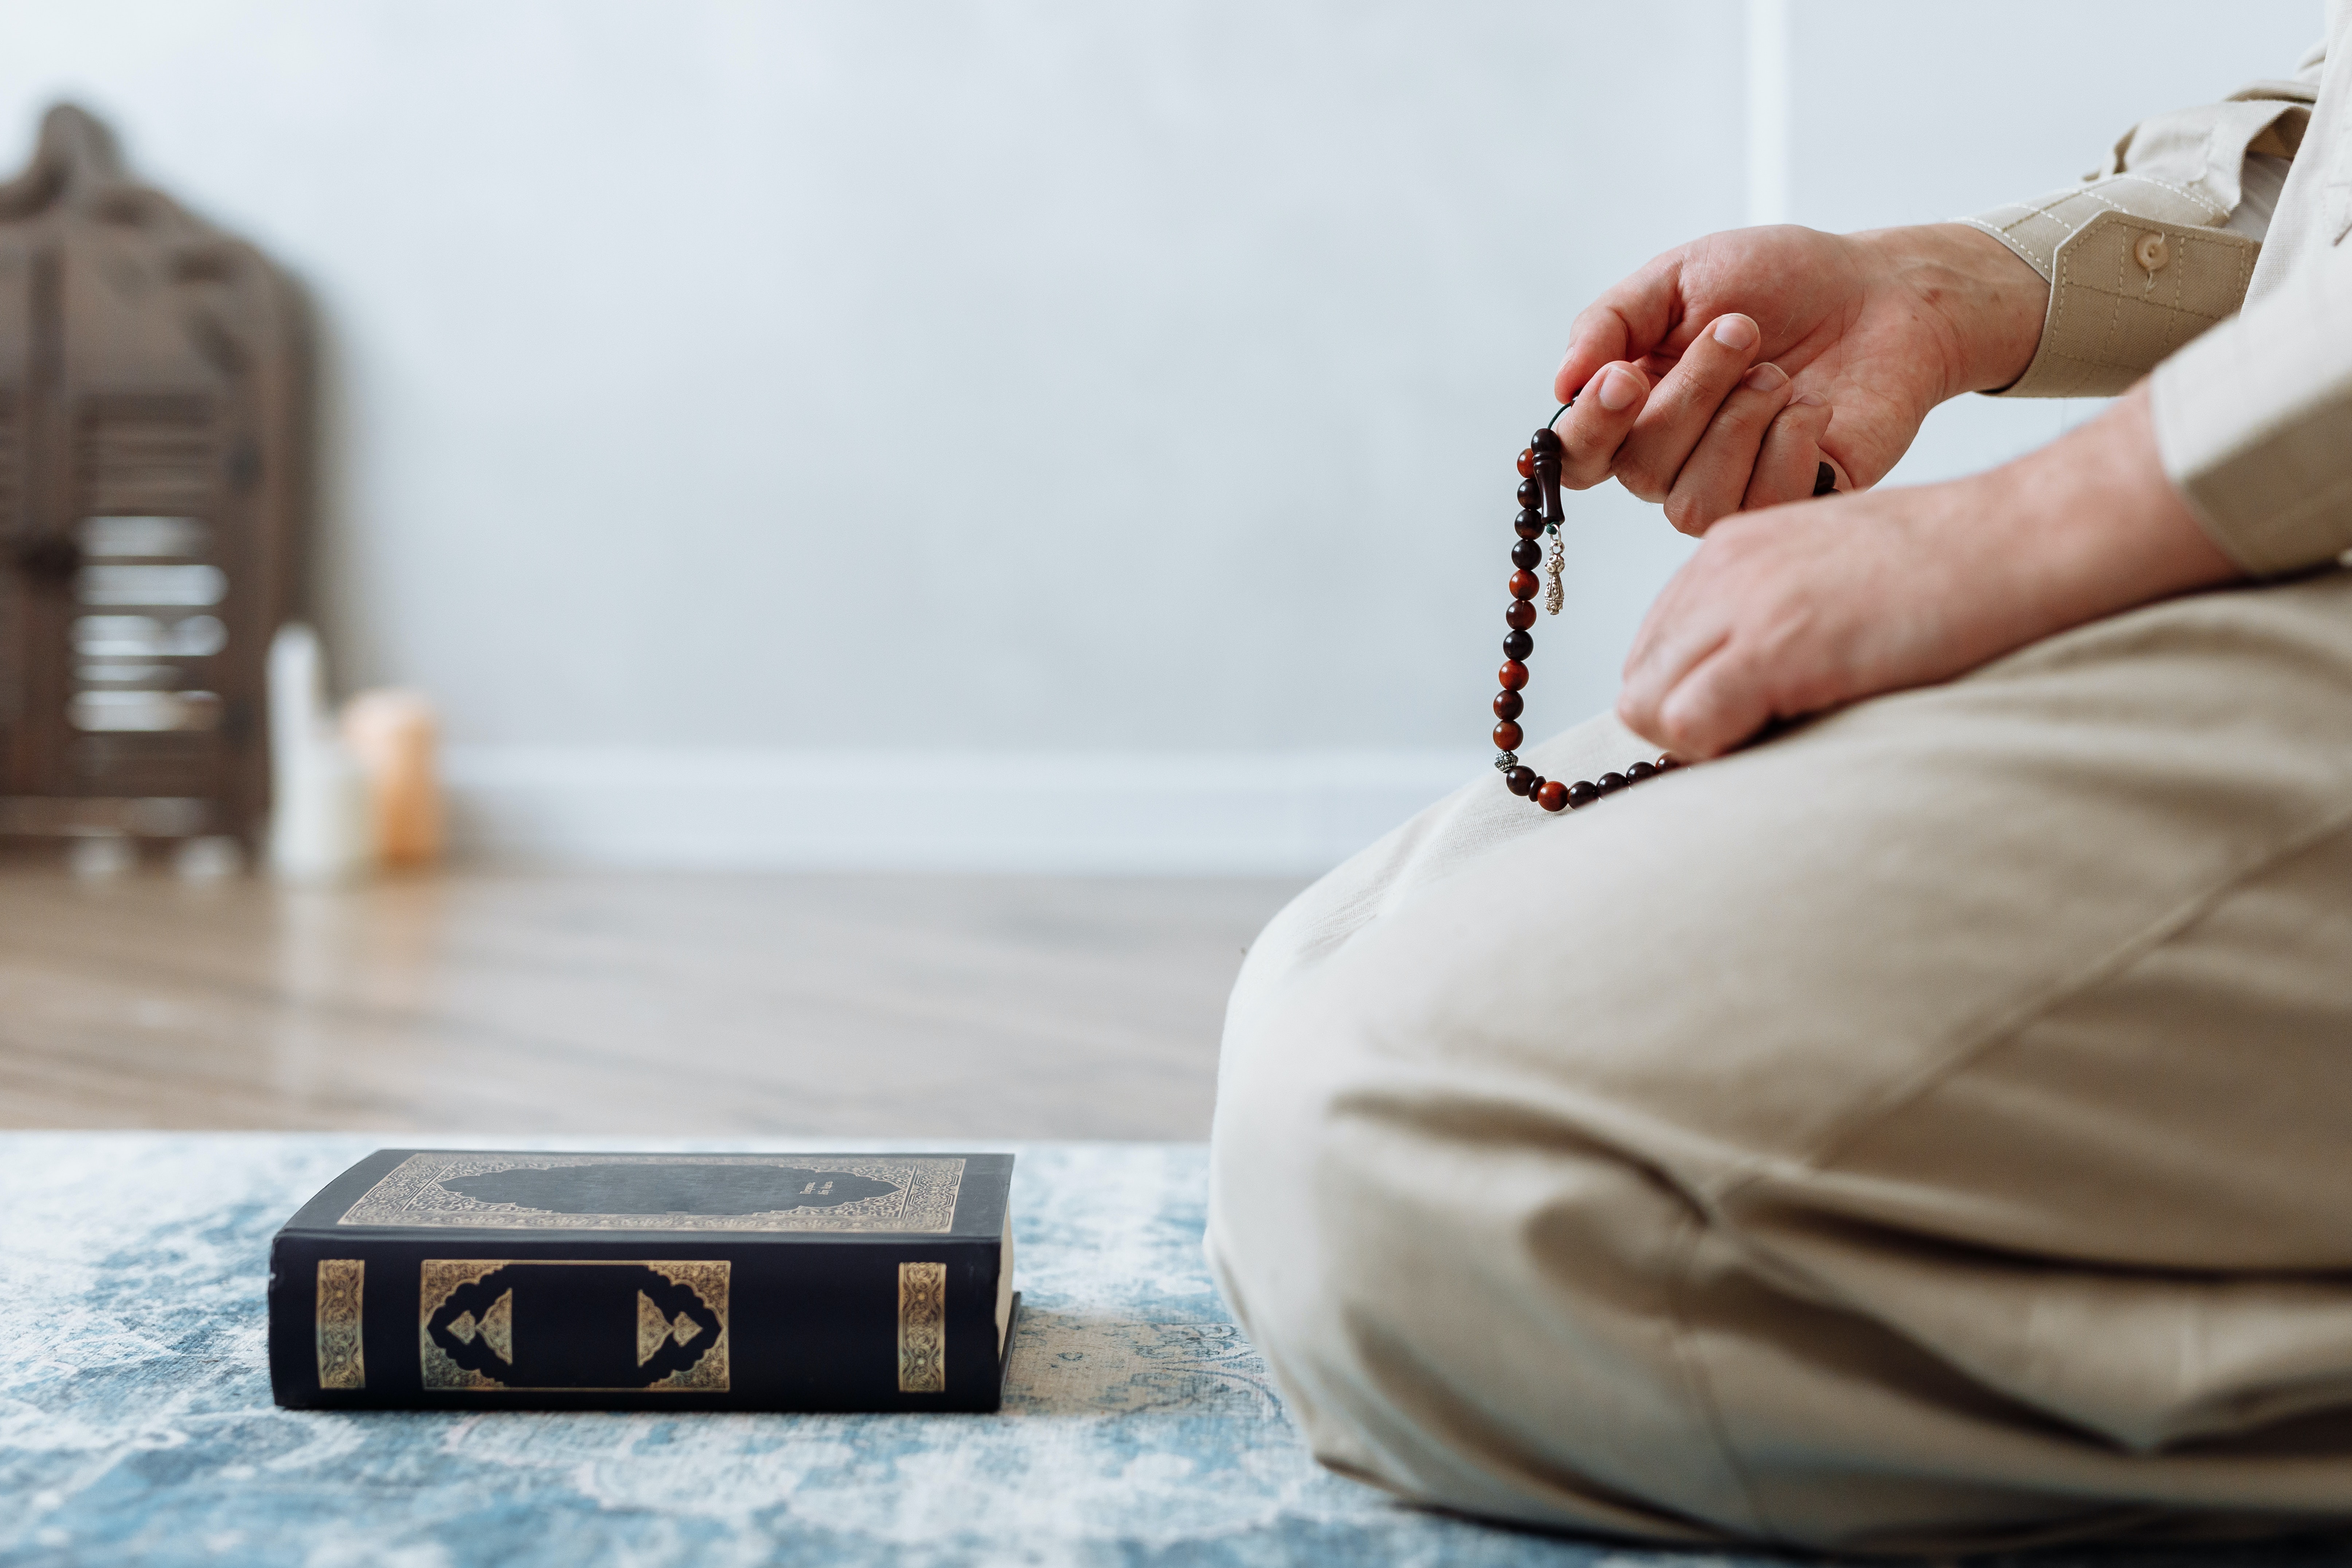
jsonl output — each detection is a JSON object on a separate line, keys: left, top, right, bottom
{"left": 268, "top": 1229, "right": 1004, "bottom": 1411}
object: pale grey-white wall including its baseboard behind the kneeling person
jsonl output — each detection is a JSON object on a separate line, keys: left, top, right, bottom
{"left": 0, "top": 0, "right": 2317, "bottom": 870}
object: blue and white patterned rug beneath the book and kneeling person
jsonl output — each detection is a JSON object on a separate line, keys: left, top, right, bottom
{"left": 0, "top": 1133, "right": 2345, "bottom": 1568}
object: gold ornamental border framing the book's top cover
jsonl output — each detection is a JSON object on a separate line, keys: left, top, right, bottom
{"left": 336, "top": 1152, "right": 964, "bottom": 1236}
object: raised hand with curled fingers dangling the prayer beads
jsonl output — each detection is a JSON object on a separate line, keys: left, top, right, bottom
{"left": 1552, "top": 223, "right": 2048, "bottom": 533}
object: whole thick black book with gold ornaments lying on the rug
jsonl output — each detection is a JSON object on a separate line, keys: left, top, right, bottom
{"left": 270, "top": 1150, "right": 1021, "bottom": 1411}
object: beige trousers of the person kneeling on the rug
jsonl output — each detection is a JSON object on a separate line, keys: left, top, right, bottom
{"left": 1209, "top": 571, "right": 2352, "bottom": 1552}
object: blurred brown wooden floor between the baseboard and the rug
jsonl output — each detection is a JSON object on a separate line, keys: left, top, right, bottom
{"left": 0, "top": 870, "right": 1296, "bottom": 1138}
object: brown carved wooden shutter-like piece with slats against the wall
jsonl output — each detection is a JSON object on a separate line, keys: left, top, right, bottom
{"left": 0, "top": 106, "right": 308, "bottom": 875}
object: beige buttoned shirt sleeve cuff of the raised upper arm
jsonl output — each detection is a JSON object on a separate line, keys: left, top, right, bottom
{"left": 1964, "top": 70, "right": 2321, "bottom": 397}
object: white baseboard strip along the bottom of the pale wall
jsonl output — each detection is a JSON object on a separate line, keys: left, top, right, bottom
{"left": 445, "top": 745, "right": 1486, "bottom": 875}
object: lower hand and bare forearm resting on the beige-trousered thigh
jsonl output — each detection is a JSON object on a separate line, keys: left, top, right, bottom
{"left": 1618, "top": 383, "right": 2239, "bottom": 762}
